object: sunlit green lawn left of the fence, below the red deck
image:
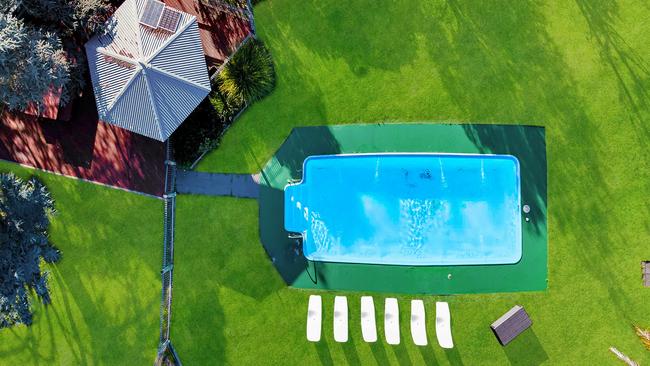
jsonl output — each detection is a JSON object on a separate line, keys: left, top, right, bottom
{"left": 0, "top": 162, "right": 162, "bottom": 365}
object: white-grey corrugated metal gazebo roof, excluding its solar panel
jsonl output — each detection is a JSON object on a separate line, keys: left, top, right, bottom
{"left": 86, "top": 0, "right": 210, "bottom": 141}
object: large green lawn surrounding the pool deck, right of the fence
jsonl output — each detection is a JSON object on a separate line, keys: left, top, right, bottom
{"left": 172, "top": 0, "right": 650, "bottom": 365}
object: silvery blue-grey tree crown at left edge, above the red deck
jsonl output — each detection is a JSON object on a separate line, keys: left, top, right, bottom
{"left": 0, "top": 14, "right": 70, "bottom": 110}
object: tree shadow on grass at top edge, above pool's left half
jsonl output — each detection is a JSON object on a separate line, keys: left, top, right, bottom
{"left": 265, "top": 0, "right": 417, "bottom": 77}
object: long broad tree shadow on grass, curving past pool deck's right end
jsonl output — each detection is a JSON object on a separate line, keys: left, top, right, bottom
{"left": 420, "top": 0, "right": 639, "bottom": 312}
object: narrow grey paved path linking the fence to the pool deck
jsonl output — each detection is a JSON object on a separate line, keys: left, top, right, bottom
{"left": 176, "top": 170, "right": 259, "bottom": 198}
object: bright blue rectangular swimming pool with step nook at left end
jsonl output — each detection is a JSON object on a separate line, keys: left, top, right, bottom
{"left": 284, "top": 154, "right": 522, "bottom": 265}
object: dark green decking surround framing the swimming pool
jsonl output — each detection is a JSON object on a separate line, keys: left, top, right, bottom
{"left": 259, "top": 123, "right": 547, "bottom": 294}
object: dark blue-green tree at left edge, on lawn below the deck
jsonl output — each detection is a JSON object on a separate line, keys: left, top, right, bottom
{"left": 0, "top": 174, "right": 61, "bottom": 328}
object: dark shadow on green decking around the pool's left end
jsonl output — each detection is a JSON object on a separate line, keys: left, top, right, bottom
{"left": 259, "top": 127, "right": 341, "bottom": 285}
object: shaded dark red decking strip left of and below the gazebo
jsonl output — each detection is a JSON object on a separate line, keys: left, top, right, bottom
{"left": 0, "top": 85, "right": 165, "bottom": 195}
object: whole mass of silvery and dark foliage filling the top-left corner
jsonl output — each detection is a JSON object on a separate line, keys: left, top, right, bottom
{"left": 0, "top": 0, "right": 113, "bottom": 110}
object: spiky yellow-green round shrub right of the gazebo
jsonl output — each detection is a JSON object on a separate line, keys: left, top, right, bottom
{"left": 217, "top": 39, "right": 275, "bottom": 105}
